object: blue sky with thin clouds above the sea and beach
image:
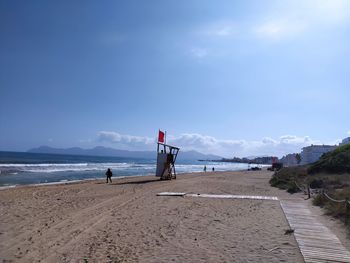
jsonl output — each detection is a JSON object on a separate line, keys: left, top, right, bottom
{"left": 0, "top": 0, "right": 350, "bottom": 157}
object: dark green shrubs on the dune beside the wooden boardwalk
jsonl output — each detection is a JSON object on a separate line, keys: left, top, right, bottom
{"left": 270, "top": 145, "right": 350, "bottom": 231}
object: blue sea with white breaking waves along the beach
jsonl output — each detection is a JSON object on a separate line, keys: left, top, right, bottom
{"left": 0, "top": 151, "right": 252, "bottom": 189}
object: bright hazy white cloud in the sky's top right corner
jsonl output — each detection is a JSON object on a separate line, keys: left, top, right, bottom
{"left": 253, "top": 0, "right": 350, "bottom": 40}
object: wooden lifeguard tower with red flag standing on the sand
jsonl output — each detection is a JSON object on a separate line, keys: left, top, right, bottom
{"left": 156, "top": 131, "right": 180, "bottom": 180}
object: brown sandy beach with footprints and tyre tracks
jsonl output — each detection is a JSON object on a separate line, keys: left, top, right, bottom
{"left": 0, "top": 171, "right": 348, "bottom": 262}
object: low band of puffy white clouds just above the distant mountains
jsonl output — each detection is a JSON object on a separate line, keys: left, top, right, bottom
{"left": 98, "top": 131, "right": 321, "bottom": 157}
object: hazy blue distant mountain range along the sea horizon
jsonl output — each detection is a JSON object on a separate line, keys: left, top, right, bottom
{"left": 27, "top": 146, "right": 222, "bottom": 160}
